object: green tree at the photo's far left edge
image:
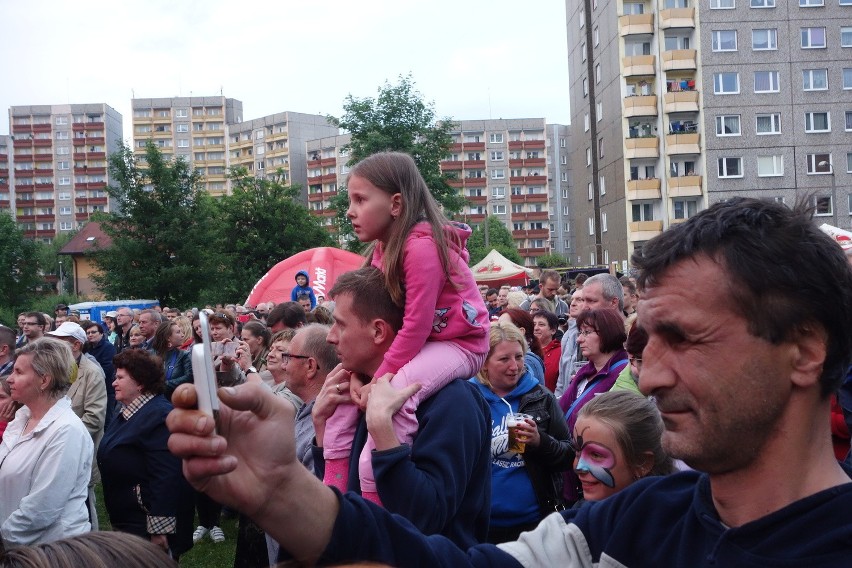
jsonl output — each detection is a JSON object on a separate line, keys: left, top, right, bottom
{"left": 0, "top": 211, "right": 42, "bottom": 308}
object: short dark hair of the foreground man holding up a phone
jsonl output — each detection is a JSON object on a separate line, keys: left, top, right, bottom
{"left": 631, "top": 197, "right": 852, "bottom": 397}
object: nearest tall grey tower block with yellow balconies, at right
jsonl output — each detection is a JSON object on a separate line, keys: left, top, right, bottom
{"left": 566, "top": 0, "right": 852, "bottom": 269}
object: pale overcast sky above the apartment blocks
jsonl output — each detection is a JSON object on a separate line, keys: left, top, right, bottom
{"left": 0, "top": 0, "right": 570, "bottom": 140}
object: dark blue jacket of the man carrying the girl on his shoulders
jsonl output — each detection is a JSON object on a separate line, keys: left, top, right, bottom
{"left": 314, "top": 380, "right": 491, "bottom": 548}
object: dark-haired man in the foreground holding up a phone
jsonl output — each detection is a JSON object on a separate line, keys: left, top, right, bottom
{"left": 169, "top": 199, "right": 852, "bottom": 567}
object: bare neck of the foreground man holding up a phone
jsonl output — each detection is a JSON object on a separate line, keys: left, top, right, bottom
{"left": 710, "top": 402, "right": 852, "bottom": 527}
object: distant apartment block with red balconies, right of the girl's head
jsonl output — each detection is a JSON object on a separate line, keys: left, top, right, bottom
{"left": 441, "top": 118, "right": 573, "bottom": 266}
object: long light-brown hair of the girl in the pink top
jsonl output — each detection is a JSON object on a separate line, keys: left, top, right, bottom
{"left": 347, "top": 152, "right": 461, "bottom": 307}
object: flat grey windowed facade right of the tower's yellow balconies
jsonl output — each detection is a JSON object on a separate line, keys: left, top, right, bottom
{"left": 699, "top": 0, "right": 852, "bottom": 229}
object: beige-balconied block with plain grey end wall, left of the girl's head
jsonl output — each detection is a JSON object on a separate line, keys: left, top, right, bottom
{"left": 228, "top": 112, "right": 338, "bottom": 203}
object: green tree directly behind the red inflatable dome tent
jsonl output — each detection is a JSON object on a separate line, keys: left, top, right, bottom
{"left": 211, "top": 168, "right": 333, "bottom": 301}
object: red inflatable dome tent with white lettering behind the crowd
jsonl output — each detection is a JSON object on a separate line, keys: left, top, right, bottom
{"left": 244, "top": 247, "right": 364, "bottom": 306}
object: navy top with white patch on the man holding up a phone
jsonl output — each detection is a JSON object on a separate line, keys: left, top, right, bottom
{"left": 319, "top": 472, "right": 852, "bottom": 568}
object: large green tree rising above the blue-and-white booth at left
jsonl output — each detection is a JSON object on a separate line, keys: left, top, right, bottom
{"left": 93, "top": 142, "right": 221, "bottom": 306}
